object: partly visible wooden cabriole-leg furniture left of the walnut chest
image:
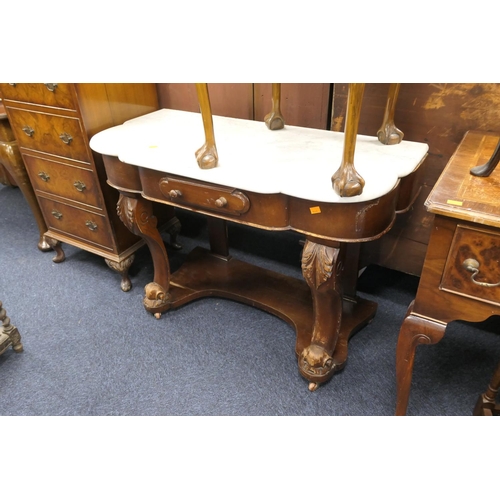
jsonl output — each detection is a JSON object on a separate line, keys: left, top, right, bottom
{"left": 0, "top": 102, "right": 51, "bottom": 251}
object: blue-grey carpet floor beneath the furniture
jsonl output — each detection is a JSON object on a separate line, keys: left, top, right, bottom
{"left": 0, "top": 185, "right": 500, "bottom": 416}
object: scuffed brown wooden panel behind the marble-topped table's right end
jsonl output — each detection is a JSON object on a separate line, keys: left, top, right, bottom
{"left": 332, "top": 83, "right": 500, "bottom": 275}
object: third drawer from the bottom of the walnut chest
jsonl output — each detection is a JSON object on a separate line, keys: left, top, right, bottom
{"left": 7, "top": 107, "right": 90, "bottom": 162}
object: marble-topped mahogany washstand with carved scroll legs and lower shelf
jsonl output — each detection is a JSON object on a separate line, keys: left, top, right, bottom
{"left": 90, "top": 103, "right": 427, "bottom": 390}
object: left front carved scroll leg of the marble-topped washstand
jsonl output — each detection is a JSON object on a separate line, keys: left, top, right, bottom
{"left": 117, "top": 193, "right": 170, "bottom": 318}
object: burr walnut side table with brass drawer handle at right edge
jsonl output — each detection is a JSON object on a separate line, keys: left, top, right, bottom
{"left": 396, "top": 131, "right": 500, "bottom": 415}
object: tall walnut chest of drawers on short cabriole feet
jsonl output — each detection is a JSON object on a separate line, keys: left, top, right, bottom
{"left": 0, "top": 83, "right": 178, "bottom": 291}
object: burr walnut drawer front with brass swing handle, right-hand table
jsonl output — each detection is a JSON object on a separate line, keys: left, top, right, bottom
{"left": 440, "top": 225, "right": 500, "bottom": 305}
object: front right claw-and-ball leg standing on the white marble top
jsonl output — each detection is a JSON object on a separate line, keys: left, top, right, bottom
{"left": 332, "top": 83, "right": 365, "bottom": 197}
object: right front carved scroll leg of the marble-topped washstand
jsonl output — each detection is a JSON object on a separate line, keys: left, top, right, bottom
{"left": 298, "top": 240, "right": 344, "bottom": 390}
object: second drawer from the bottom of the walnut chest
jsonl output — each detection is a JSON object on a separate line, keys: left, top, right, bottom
{"left": 24, "top": 154, "right": 104, "bottom": 208}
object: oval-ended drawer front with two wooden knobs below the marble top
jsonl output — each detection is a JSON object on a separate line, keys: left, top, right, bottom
{"left": 157, "top": 177, "right": 250, "bottom": 216}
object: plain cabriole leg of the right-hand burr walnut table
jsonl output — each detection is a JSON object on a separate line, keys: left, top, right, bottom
{"left": 396, "top": 304, "right": 447, "bottom": 415}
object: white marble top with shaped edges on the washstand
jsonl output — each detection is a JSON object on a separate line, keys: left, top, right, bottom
{"left": 90, "top": 109, "right": 428, "bottom": 203}
